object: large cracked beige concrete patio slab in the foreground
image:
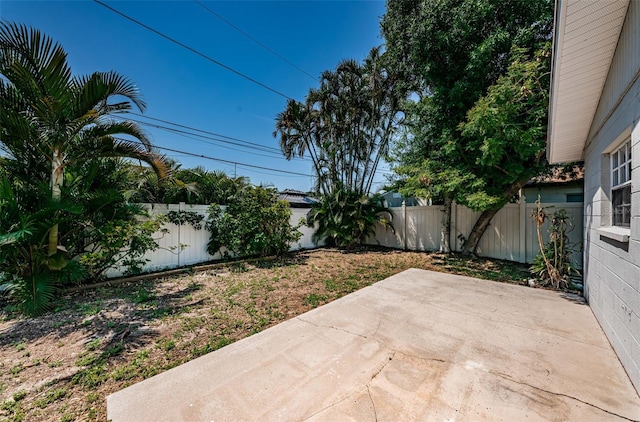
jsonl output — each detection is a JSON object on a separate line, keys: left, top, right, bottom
{"left": 107, "top": 269, "right": 640, "bottom": 422}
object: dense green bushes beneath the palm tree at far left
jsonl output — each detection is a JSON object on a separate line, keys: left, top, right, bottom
{"left": 0, "top": 160, "right": 168, "bottom": 315}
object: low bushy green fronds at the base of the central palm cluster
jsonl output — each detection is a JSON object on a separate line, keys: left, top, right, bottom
{"left": 308, "top": 189, "right": 392, "bottom": 249}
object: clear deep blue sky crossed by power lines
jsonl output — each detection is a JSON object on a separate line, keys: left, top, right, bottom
{"left": 0, "top": 0, "right": 385, "bottom": 190}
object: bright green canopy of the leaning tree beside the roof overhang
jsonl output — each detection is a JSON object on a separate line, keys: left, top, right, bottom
{"left": 456, "top": 43, "right": 551, "bottom": 211}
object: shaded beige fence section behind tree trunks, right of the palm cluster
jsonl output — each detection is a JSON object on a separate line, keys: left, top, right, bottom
{"left": 367, "top": 201, "right": 583, "bottom": 267}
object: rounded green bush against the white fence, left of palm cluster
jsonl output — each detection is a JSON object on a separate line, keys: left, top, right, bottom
{"left": 206, "top": 186, "right": 302, "bottom": 257}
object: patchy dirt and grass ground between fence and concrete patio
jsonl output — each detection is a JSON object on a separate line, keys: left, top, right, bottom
{"left": 0, "top": 249, "right": 528, "bottom": 421}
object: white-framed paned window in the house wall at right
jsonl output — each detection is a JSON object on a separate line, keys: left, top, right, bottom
{"left": 611, "top": 141, "right": 631, "bottom": 227}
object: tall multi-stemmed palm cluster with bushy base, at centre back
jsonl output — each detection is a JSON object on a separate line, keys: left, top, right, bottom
{"left": 274, "top": 48, "right": 406, "bottom": 248}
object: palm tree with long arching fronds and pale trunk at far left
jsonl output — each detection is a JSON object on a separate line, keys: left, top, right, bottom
{"left": 0, "top": 21, "right": 166, "bottom": 256}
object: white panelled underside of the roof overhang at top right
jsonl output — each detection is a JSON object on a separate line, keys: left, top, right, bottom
{"left": 547, "top": 0, "right": 630, "bottom": 163}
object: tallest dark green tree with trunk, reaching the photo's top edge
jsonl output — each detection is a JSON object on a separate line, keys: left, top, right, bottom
{"left": 382, "top": 0, "right": 553, "bottom": 252}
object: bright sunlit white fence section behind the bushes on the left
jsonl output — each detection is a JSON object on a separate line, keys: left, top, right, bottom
{"left": 106, "top": 202, "right": 322, "bottom": 278}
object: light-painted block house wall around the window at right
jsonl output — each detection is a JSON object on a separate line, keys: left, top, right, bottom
{"left": 584, "top": 0, "right": 640, "bottom": 391}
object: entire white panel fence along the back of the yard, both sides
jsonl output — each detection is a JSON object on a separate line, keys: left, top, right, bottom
{"left": 107, "top": 201, "right": 583, "bottom": 277}
